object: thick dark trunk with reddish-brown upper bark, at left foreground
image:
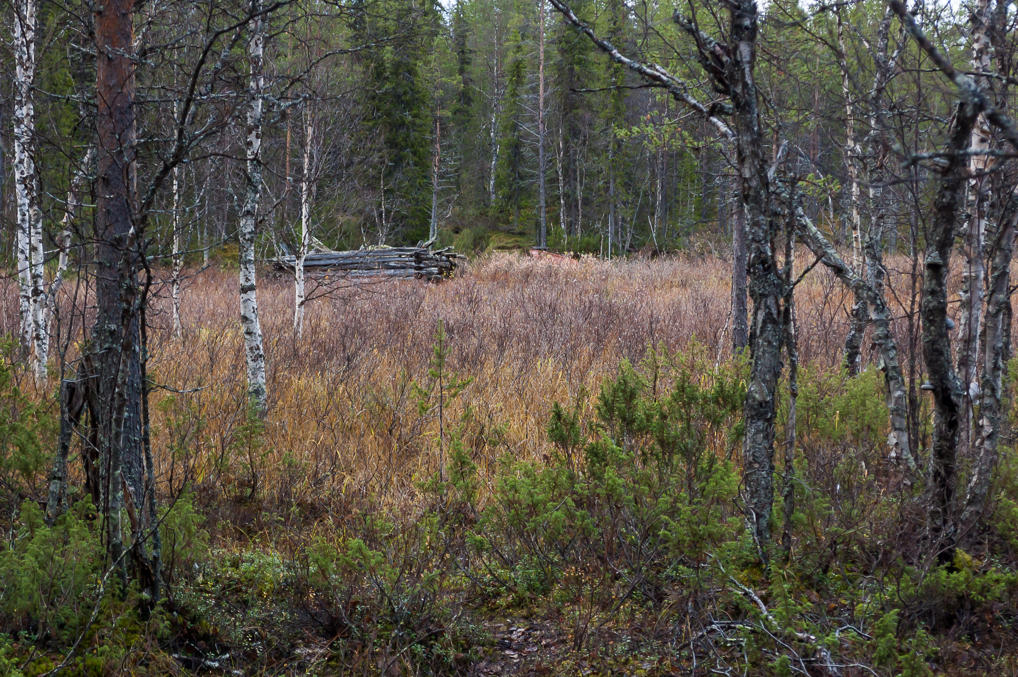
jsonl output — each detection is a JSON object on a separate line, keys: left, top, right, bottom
{"left": 94, "top": 0, "right": 159, "bottom": 603}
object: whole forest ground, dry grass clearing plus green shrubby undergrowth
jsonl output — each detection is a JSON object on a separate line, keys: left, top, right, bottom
{"left": 0, "top": 250, "right": 1018, "bottom": 675}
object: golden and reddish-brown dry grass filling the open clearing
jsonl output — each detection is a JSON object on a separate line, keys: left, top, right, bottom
{"left": 0, "top": 249, "right": 944, "bottom": 529}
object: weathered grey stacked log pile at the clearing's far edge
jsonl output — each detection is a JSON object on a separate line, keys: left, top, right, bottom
{"left": 273, "top": 245, "right": 464, "bottom": 282}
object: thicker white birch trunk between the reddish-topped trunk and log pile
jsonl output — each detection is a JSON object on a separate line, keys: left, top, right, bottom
{"left": 239, "top": 0, "right": 267, "bottom": 416}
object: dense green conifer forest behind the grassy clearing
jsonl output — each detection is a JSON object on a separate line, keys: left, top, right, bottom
{"left": 0, "top": 1, "right": 985, "bottom": 259}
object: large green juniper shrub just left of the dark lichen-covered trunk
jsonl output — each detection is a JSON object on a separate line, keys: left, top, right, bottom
{"left": 474, "top": 350, "right": 745, "bottom": 604}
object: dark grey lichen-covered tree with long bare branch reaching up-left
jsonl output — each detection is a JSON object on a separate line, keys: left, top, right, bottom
{"left": 551, "top": 0, "right": 786, "bottom": 563}
